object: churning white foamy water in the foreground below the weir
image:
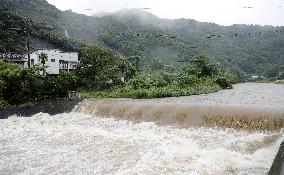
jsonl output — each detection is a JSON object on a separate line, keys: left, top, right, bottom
{"left": 0, "top": 113, "right": 284, "bottom": 175}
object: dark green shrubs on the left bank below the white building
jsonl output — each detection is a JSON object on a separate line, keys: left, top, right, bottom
{"left": 0, "top": 61, "right": 78, "bottom": 106}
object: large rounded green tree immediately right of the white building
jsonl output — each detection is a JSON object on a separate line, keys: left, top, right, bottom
{"left": 77, "top": 45, "right": 123, "bottom": 89}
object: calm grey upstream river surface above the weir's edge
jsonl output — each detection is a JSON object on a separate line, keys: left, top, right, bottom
{"left": 143, "top": 83, "right": 284, "bottom": 107}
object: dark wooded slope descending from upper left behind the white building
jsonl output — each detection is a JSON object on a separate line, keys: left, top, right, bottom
{"left": 0, "top": 6, "right": 84, "bottom": 53}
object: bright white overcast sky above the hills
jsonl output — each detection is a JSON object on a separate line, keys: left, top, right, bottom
{"left": 47, "top": 0, "right": 284, "bottom": 26}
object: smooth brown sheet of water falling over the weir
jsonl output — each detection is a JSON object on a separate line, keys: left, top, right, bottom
{"left": 74, "top": 99, "right": 284, "bottom": 130}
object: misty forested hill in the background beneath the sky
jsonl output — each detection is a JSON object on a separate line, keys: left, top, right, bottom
{"left": 0, "top": 0, "right": 284, "bottom": 75}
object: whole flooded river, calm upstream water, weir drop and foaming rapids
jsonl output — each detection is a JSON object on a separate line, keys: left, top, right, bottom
{"left": 0, "top": 83, "right": 284, "bottom": 175}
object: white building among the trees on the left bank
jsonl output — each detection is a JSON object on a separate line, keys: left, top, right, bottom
{"left": 25, "top": 49, "right": 79, "bottom": 75}
